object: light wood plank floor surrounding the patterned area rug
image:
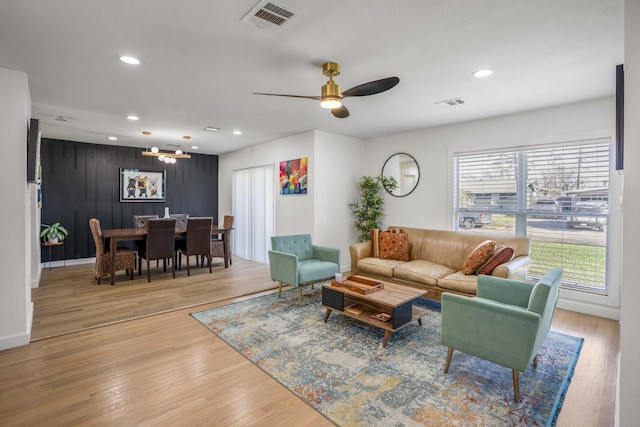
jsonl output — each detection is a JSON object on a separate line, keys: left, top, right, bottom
{"left": 0, "top": 258, "right": 619, "bottom": 426}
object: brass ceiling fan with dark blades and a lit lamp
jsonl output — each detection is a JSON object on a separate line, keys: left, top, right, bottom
{"left": 254, "top": 62, "right": 400, "bottom": 119}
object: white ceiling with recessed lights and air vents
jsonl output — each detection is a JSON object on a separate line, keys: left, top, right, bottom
{"left": 0, "top": 0, "right": 624, "bottom": 154}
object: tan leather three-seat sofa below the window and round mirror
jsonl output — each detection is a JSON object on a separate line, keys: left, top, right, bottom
{"left": 349, "top": 226, "right": 531, "bottom": 300}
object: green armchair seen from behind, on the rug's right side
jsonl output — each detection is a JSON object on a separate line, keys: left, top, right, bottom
{"left": 440, "top": 268, "right": 562, "bottom": 402}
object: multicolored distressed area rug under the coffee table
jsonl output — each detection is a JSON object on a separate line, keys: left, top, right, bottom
{"left": 191, "top": 287, "right": 583, "bottom": 427}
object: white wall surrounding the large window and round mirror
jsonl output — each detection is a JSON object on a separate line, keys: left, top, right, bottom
{"left": 364, "top": 96, "right": 622, "bottom": 319}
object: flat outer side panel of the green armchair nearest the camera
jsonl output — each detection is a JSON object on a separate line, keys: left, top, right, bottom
{"left": 440, "top": 292, "right": 540, "bottom": 372}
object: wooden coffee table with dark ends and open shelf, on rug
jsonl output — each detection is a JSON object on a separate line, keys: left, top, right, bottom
{"left": 322, "top": 276, "right": 427, "bottom": 347}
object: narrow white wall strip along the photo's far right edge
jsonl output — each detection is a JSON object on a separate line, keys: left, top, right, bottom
{"left": 612, "top": 0, "right": 640, "bottom": 427}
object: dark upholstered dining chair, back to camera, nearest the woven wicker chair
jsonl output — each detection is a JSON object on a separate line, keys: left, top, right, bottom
{"left": 138, "top": 218, "right": 176, "bottom": 282}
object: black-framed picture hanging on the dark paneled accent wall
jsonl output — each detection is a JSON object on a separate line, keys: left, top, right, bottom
{"left": 120, "top": 168, "right": 167, "bottom": 202}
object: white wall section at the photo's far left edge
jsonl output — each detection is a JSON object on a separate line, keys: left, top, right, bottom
{"left": 0, "top": 68, "right": 32, "bottom": 350}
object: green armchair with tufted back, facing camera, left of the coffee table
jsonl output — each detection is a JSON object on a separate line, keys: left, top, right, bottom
{"left": 269, "top": 234, "right": 340, "bottom": 304}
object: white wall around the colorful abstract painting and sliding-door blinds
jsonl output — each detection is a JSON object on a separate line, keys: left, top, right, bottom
{"left": 218, "top": 131, "right": 363, "bottom": 270}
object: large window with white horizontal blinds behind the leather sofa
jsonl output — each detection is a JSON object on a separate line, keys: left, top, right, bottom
{"left": 453, "top": 139, "right": 611, "bottom": 294}
